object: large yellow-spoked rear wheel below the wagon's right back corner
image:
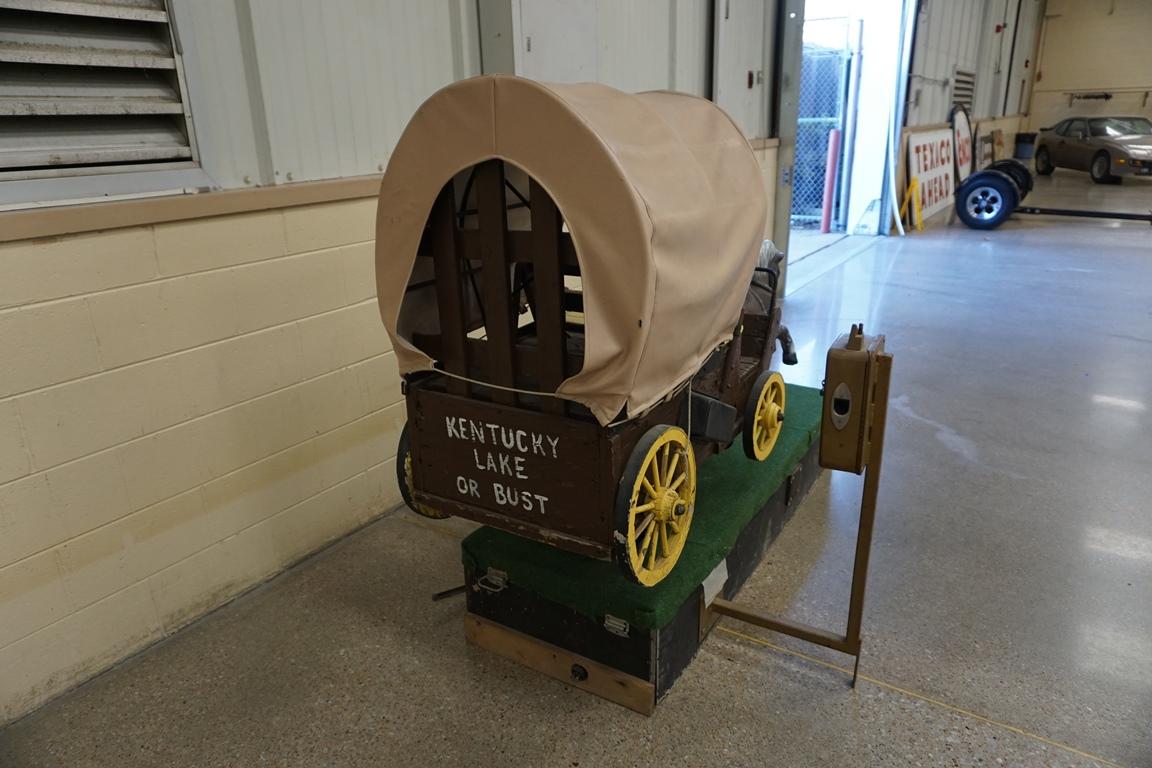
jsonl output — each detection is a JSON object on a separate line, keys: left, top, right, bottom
{"left": 615, "top": 424, "right": 696, "bottom": 587}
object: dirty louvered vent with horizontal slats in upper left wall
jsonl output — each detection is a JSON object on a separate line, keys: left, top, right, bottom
{"left": 0, "top": 0, "right": 197, "bottom": 182}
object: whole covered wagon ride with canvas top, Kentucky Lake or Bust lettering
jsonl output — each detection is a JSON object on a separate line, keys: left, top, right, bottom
{"left": 377, "top": 76, "right": 794, "bottom": 586}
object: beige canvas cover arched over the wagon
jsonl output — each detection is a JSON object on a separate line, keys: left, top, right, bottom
{"left": 376, "top": 75, "right": 766, "bottom": 424}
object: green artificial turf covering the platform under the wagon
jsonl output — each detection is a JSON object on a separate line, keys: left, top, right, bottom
{"left": 462, "top": 385, "right": 821, "bottom": 630}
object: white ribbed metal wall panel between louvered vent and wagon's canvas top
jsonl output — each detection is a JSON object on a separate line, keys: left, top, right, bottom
{"left": 250, "top": 0, "right": 476, "bottom": 183}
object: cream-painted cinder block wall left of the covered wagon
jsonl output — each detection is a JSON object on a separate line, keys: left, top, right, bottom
{"left": 0, "top": 198, "right": 404, "bottom": 723}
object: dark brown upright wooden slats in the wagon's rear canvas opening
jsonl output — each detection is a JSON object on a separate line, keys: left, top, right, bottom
{"left": 412, "top": 160, "right": 584, "bottom": 413}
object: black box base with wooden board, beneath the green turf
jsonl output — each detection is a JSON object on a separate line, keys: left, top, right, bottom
{"left": 464, "top": 442, "right": 820, "bottom": 715}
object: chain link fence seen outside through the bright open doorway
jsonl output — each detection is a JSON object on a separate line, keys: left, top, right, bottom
{"left": 791, "top": 30, "right": 851, "bottom": 229}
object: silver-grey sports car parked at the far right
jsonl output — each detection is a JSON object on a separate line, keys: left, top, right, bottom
{"left": 1036, "top": 117, "right": 1152, "bottom": 184}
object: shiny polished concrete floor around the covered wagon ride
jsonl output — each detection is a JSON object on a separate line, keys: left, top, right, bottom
{"left": 0, "top": 173, "right": 1152, "bottom": 768}
